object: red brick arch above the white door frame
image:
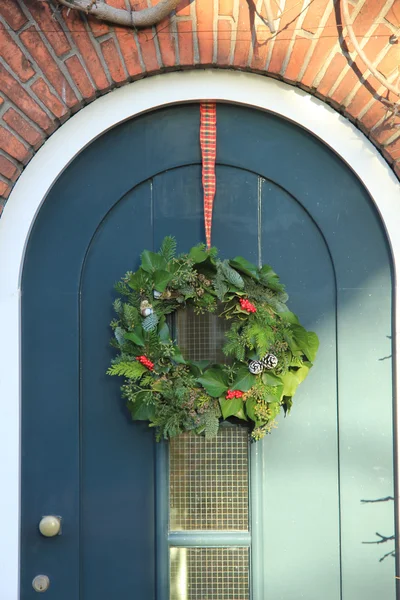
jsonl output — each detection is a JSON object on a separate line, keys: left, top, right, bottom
{"left": 0, "top": 0, "right": 400, "bottom": 212}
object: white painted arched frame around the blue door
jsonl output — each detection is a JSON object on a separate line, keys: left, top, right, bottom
{"left": 0, "top": 70, "right": 400, "bottom": 600}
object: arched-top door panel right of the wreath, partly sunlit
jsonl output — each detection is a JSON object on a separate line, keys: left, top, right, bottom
{"left": 260, "top": 181, "right": 340, "bottom": 600}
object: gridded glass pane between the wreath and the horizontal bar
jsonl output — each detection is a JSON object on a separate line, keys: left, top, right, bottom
{"left": 169, "top": 426, "right": 249, "bottom": 531}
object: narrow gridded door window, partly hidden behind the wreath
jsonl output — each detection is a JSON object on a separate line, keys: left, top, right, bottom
{"left": 165, "top": 309, "right": 251, "bottom": 600}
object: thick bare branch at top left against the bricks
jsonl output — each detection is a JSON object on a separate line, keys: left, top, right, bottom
{"left": 56, "top": 0, "right": 180, "bottom": 27}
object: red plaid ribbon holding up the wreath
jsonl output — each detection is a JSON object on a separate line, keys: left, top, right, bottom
{"left": 200, "top": 102, "right": 217, "bottom": 248}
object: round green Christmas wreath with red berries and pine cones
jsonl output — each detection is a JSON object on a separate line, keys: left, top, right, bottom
{"left": 107, "top": 237, "right": 318, "bottom": 440}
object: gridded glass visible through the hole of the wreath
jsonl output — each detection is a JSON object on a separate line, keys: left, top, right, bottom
{"left": 176, "top": 308, "right": 230, "bottom": 363}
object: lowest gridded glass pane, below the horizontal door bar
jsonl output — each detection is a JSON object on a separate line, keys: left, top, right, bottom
{"left": 170, "top": 548, "right": 250, "bottom": 600}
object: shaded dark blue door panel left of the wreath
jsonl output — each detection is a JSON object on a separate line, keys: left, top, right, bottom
{"left": 80, "top": 182, "right": 155, "bottom": 598}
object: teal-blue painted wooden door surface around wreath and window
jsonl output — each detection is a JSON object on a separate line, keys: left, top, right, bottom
{"left": 21, "top": 104, "right": 396, "bottom": 600}
